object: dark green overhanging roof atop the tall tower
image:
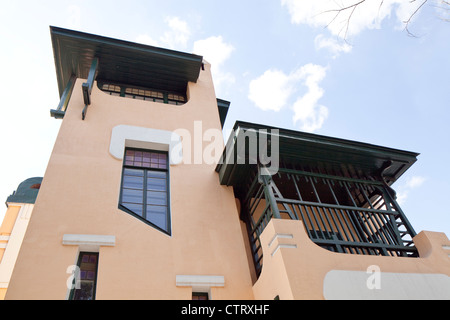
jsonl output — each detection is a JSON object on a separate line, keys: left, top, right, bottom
{"left": 50, "top": 26, "right": 203, "bottom": 96}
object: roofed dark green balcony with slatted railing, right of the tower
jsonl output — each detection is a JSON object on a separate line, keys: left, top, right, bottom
{"left": 216, "top": 122, "right": 418, "bottom": 277}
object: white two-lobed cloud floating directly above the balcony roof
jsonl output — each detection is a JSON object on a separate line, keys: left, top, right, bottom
{"left": 248, "top": 63, "right": 328, "bottom": 132}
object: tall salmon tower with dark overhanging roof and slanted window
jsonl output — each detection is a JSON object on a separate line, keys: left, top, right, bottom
{"left": 6, "top": 27, "right": 253, "bottom": 299}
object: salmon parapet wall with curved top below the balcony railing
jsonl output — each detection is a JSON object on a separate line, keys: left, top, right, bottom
{"left": 254, "top": 219, "right": 450, "bottom": 300}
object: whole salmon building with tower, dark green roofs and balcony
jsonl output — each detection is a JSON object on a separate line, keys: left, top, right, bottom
{"left": 2, "top": 27, "right": 450, "bottom": 300}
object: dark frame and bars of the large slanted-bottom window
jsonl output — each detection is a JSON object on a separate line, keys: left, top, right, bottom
{"left": 119, "top": 147, "right": 172, "bottom": 236}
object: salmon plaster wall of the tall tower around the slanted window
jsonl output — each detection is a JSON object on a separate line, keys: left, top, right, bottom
{"left": 6, "top": 64, "right": 253, "bottom": 299}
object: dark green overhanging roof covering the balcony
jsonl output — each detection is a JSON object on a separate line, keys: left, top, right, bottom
{"left": 216, "top": 121, "right": 419, "bottom": 186}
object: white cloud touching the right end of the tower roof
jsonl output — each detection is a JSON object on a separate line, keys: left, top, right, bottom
{"left": 193, "top": 36, "right": 235, "bottom": 92}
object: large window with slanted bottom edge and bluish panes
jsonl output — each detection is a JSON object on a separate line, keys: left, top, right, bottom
{"left": 119, "top": 149, "right": 170, "bottom": 234}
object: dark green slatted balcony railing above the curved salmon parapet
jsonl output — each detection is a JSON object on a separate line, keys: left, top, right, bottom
{"left": 244, "top": 169, "right": 417, "bottom": 275}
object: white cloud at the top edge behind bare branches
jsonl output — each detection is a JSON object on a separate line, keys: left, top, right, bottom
{"left": 281, "top": 0, "right": 428, "bottom": 38}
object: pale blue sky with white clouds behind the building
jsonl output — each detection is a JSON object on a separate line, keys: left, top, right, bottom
{"left": 0, "top": 0, "right": 450, "bottom": 237}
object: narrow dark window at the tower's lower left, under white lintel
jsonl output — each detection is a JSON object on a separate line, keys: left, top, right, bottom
{"left": 69, "top": 252, "right": 98, "bottom": 300}
